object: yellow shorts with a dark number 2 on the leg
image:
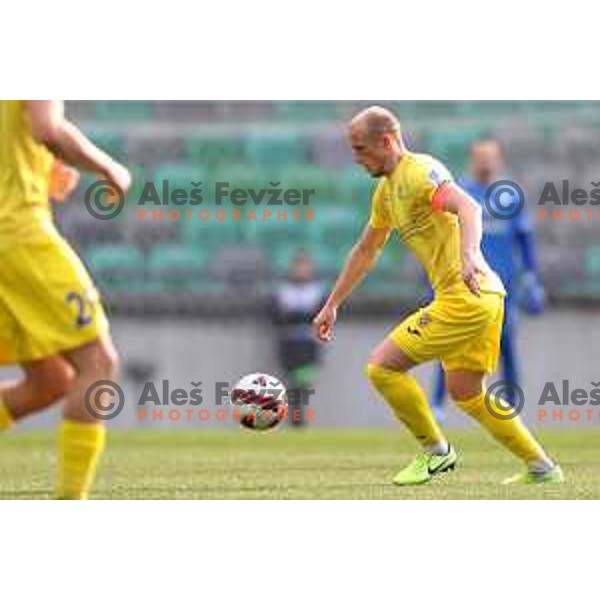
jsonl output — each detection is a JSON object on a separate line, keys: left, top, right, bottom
{"left": 0, "top": 227, "right": 108, "bottom": 364}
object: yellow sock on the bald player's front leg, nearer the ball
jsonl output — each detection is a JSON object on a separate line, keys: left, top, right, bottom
{"left": 367, "top": 364, "right": 447, "bottom": 453}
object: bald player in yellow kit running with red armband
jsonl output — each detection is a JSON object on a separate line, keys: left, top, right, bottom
{"left": 314, "top": 106, "right": 563, "bottom": 485}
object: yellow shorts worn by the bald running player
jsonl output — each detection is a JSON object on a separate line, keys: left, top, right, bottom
{"left": 390, "top": 292, "right": 504, "bottom": 373}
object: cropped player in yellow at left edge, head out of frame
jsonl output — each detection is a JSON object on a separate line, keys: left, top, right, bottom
{"left": 0, "top": 100, "right": 131, "bottom": 499}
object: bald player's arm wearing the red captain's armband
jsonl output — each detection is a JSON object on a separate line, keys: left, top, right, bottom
{"left": 432, "top": 181, "right": 484, "bottom": 295}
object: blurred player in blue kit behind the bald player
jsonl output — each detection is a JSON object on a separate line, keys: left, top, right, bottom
{"left": 432, "top": 139, "right": 544, "bottom": 418}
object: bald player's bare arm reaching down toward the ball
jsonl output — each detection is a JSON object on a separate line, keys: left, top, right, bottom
{"left": 313, "top": 223, "right": 391, "bottom": 342}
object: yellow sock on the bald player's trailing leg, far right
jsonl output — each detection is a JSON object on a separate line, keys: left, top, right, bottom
{"left": 457, "top": 392, "right": 552, "bottom": 466}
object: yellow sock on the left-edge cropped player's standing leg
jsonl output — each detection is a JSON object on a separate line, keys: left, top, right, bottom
{"left": 56, "top": 420, "right": 106, "bottom": 500}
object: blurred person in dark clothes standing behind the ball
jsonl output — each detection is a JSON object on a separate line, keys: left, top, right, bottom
{"left": 271, "top": 252, "right": 325, "bottom": 426}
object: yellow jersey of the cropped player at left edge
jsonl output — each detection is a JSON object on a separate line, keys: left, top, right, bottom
{"left": 0, "top": 100, "right": 54, "bottom": 244}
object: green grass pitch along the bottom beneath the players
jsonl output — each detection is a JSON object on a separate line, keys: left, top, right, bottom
{"left": 0, "top": 429, "right": 600, "bottom": 499}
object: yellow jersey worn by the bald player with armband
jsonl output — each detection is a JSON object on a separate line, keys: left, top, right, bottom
{"left": 370, "top": 153, "right": 505, "bottom": 294}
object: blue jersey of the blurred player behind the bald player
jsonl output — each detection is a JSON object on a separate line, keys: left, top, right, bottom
{"left": 457, "top": 176, "right": 536, "bottom": 297}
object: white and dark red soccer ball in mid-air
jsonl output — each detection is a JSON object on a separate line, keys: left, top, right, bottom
{"left": 230, "top": 373, "right": 288, "bottom": 431}
